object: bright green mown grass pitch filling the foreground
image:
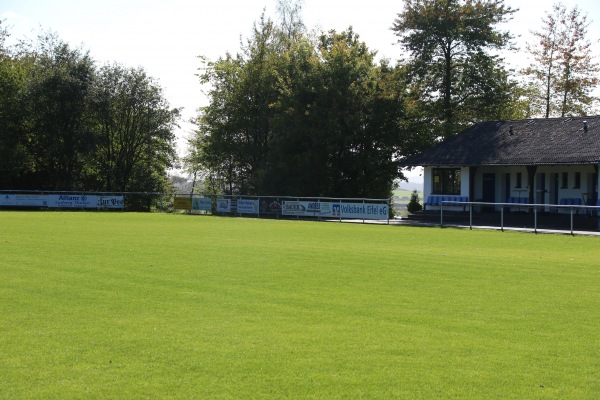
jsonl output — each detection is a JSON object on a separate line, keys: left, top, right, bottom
{"left": 0, "top": 212, "right": 600, "bottom": 399}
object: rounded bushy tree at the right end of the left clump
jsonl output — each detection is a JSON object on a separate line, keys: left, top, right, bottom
{"left": 91, "top": 64, "right": 180, "bottom": 191}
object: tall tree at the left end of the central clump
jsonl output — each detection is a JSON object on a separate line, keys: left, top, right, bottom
{"left": 198, "top": 16, "right": 281, "bottom": 194}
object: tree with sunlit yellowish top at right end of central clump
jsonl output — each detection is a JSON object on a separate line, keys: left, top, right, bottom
{"left": 314, "top": 28, "right": 403, "bottom": 198}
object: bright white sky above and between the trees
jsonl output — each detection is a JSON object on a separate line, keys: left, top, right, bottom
{"left": 0, "top": 0, "right": 600, "bottom": 181}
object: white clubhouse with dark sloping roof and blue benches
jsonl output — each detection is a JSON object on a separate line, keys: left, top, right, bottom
{"left": 405, "top": 116, "right": 600, "bottom": 210}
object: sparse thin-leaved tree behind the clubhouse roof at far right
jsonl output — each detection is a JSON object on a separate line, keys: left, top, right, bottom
{"left": 524, "top": 3, "right": 600, "bottom": 118}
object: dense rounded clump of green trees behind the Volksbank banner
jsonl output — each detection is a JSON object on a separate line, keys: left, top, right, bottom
{"left": 188, "top": 18, "right": 403, "bottom": 198}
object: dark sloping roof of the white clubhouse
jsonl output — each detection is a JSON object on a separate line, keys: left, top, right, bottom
{"left": 403, "top": 116, "right": 600, "bottom": 166}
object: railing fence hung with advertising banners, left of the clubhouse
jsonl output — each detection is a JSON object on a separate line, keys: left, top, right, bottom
{"left": 0, "top": 190, "right": 391, "bottom": 223}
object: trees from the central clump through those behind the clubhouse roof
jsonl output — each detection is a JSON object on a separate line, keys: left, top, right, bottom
{"left": 184, "top": 0, "right": 598, "bottom": 198}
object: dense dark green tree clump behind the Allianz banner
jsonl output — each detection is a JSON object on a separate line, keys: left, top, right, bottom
{"left": 0, "top": 25, "right": 179, "bottom": 192}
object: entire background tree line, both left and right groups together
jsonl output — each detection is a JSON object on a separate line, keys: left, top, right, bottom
{"left": 0, "top": 0, "right": 600, "bottom": 202}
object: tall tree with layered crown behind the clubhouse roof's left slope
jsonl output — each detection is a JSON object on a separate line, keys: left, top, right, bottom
{"left": 392, "top": 0, "right": 515, "bottom": 138}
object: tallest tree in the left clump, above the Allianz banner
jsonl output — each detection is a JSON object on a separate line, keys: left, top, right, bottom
{"left": 18, "top": 32, "right": 95, "bottom": 190}
